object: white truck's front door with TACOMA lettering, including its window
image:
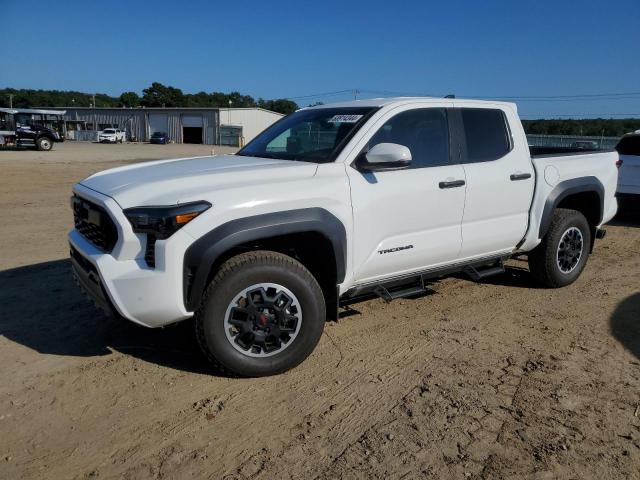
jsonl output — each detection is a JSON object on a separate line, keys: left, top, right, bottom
{"left": 347, "top": 107, "right": 465, "bottom": 284}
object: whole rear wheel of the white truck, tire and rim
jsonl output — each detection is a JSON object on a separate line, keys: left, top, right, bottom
{"left": 529, "top": 208, "right": 591, "bottom": 288}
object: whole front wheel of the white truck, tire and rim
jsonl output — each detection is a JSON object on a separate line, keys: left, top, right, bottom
{"left": 195, "top": 251, "right": 326, "bottom": 377}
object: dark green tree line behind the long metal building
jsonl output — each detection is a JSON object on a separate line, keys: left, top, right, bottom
{"left": 0, "top": 82, "right": 298, "bottom": 114}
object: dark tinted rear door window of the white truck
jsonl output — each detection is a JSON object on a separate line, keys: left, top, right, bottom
{"left": 461, "top": 108, "right": 511, "bottom": 163}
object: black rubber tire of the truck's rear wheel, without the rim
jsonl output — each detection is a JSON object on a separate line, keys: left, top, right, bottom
{"left": 529, "top": 208, "right": 593, "bottom": 288}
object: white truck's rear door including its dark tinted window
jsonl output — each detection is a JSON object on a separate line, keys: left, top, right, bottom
{"left": 452, "top": 107, "right": 535, "bottom": 258}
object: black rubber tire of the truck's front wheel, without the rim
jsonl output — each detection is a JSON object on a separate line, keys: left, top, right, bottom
{"left": 194, "top": 250, "right": 326, "bottom": 377}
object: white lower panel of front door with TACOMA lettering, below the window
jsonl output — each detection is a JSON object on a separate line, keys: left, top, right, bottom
{"left": 348, "top": 165, "right": 465, "bottom": 283}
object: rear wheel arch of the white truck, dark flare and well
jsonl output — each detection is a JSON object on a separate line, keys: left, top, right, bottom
{"left": 538, "top": 176, "right": 605, "bottom": 240}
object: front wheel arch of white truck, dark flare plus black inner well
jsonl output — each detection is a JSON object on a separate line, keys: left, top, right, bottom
{"left": 183, "top": 208, "right": 347, "bottom": 317}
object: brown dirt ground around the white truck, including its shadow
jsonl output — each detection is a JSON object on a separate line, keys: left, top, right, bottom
{"left": 0, "top": 143, "right": 640, "bottom": 479}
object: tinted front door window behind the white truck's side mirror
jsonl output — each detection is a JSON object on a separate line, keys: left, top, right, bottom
{"left": 368, "top": 108, "right": 449, "bottom": 168}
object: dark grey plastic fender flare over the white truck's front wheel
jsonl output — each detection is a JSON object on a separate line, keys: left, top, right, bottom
{"left": 183, "top": 208, "right": 347, "bottom": 311}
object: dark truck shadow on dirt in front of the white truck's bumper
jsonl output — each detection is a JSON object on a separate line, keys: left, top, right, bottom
{"left": 0, "top": 260, "right": 216, "bottom": 374}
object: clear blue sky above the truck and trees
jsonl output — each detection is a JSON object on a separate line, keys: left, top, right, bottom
{"left": 0, "top": 0, "right": 640, "bottom": 117}
